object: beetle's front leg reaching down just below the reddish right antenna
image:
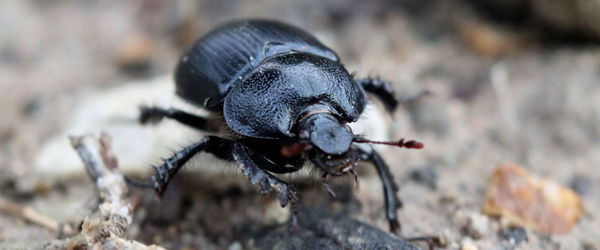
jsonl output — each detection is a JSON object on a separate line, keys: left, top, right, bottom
{"left": 358, "top": 148, "right": 402, "bottom": 233}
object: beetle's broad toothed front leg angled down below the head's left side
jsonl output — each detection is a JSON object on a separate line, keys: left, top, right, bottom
{"left": 232, "top": 143, "right": 300, "bottom": 226}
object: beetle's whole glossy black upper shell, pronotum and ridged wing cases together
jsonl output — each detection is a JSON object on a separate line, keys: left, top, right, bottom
{"left": 175, "top": 20, "right": 366, "bottom": 138}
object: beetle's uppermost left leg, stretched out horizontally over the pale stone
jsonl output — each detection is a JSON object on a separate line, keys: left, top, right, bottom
{"left": 139, "top": 106, "right": 214, "bottom": 131}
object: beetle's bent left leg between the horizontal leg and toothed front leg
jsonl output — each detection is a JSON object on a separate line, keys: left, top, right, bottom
{"left": 152, "top": 136, "right": 230, "bottom": 198}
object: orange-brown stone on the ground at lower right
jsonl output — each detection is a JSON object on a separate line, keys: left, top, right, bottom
{"left": 483, "top": 164, "right": 582, "bottom": 234}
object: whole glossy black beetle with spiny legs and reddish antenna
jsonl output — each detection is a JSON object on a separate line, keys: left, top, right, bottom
{"left": 140, "top": 20, "right": 423, "bottom": 232}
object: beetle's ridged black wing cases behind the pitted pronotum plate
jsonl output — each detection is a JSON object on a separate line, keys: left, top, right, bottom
{"left": 175, "top": 20, "right": 339, "bottom": 110}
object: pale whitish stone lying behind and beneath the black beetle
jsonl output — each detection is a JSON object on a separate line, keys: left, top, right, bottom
{"left": 32, "top": 75, "right": 389, "bottom": 186}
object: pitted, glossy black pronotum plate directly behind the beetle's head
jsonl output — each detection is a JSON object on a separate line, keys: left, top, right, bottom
{"left": 224, "top": 53, "right": 365, "bottom": 139}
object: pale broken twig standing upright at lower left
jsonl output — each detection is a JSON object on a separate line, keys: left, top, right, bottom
{"left": 45, "top": 134, "right": 162, "bottom": 249}
